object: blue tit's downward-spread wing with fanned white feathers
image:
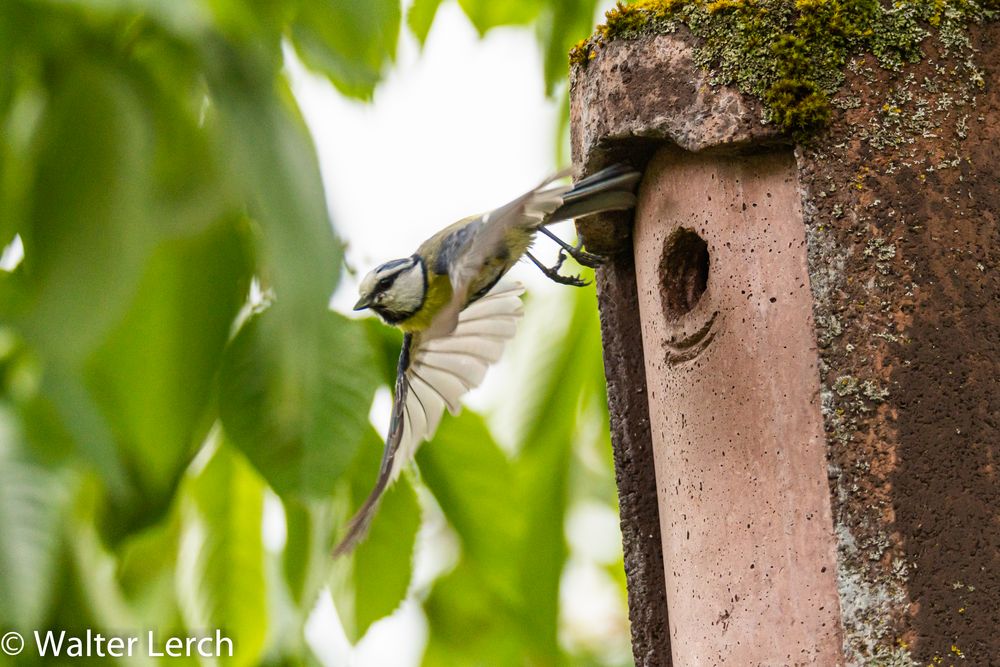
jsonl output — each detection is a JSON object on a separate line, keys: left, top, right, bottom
{"left": 333, "top": 283, "right": 524, "bottom": 556}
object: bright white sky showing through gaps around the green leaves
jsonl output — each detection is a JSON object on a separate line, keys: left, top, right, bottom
{"left": 290, "top": 2, "right": 627, "bottom": 667}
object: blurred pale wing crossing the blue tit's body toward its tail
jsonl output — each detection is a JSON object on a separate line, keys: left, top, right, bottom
{"left": 423, "top": 169, "right": 572, "bottom": 339}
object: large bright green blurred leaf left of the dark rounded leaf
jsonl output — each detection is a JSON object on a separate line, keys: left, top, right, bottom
{"left": 87, "top": 220, "right": 250, "bottom": 532}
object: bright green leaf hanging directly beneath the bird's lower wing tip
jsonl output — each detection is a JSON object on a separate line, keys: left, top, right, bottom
{"left": 334, "top": 431, "right": 420, "bottom": 642}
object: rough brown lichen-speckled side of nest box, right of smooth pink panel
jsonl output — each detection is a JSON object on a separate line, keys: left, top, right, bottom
{"left": 798, "top": 23, "right": 1000, "bottom": 665}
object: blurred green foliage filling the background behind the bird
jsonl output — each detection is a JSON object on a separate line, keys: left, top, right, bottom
{"left": 0, "top": 0, "right": 627, "bottom": 665}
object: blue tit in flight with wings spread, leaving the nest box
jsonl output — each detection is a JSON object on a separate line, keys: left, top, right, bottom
{"left": 334, "top": 164, "right": 640, "bottom": 555}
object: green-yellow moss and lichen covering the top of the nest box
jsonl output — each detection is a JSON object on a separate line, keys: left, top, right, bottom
{"left": 570, "top": 0, "right": 1000, "bottom": 140}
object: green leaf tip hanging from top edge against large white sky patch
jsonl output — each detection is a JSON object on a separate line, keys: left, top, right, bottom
{"left": 292, "top": 0, "right": 401, "bottom": 100}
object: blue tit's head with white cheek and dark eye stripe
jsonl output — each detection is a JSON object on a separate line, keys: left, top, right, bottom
{"left": 354, "top": 255, "right": 427, "bottom": 324}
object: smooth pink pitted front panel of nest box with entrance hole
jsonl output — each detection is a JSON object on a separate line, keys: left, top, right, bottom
{"left": 634, "top": 149, "right": 843, "bottom": 667}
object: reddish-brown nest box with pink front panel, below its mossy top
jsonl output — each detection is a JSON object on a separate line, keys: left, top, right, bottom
{"left": 571, "top": 23, "right": 1000, "bottom": 667}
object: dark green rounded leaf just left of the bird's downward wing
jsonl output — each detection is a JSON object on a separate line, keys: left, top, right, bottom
{"left": 219, "top": 308, "right": 378, "bottom": 497}
